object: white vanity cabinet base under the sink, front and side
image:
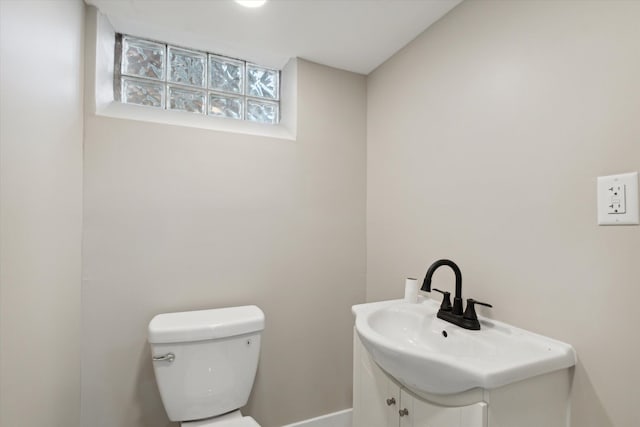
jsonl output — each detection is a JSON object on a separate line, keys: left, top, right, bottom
{"left": 352, "top": 330, "right": 571, "bottom": 427}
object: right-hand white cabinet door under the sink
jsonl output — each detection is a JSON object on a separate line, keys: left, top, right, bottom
{"left": 400, "top": 390, "right": 487, "bottom": 427}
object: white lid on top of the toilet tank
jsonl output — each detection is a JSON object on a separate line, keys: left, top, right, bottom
{"left": 148, "top": 305, "right": 264, "bottom": 344}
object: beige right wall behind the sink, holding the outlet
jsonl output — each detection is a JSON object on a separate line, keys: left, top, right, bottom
{"left": 367, "top": 1, "right": 640, "bottom": 427}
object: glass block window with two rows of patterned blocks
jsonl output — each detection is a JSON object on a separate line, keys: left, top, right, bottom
{"left": 114, "top": 34, "right": 280, "bottom": 124}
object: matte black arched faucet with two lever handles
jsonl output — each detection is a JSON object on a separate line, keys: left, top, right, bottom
{"left": 420, "top": 259, "right": 492, "bottom": 331}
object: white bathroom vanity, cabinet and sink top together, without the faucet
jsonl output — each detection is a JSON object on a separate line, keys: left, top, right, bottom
{"left": 353, "top": 300, "right": 576, "bottom": 427}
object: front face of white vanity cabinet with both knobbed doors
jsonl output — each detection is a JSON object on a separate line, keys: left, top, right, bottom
{"left": 353, "top": 334, "right": 487, "bottom": 427}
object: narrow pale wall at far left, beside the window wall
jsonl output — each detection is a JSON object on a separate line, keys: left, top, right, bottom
{"left": 0, "top": 0, "right": 84, "bottom": 427}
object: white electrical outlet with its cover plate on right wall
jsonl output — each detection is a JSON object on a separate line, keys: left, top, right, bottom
{"left": 598, "top": 172, "right": 640, "bottom": 225}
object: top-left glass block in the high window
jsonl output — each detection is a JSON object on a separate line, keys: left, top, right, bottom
{"left": 122, "top": 36, "right": 165, "bottom": 80}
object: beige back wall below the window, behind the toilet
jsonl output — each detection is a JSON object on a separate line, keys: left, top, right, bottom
{"left": 82, "top": 61, "right": 366, "bottom": 427}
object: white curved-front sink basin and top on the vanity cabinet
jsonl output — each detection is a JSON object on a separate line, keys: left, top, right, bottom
{"left": 352, "top": 299, "right": 576, "bottom": 395}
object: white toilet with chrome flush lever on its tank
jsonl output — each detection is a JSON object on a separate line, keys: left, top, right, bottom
{"left": 148, "top": 305, "right": 264, "bottom": 427}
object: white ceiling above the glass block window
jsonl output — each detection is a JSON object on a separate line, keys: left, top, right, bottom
{"left": 85, "top": 0, "right": 462, "bottom": 74}
